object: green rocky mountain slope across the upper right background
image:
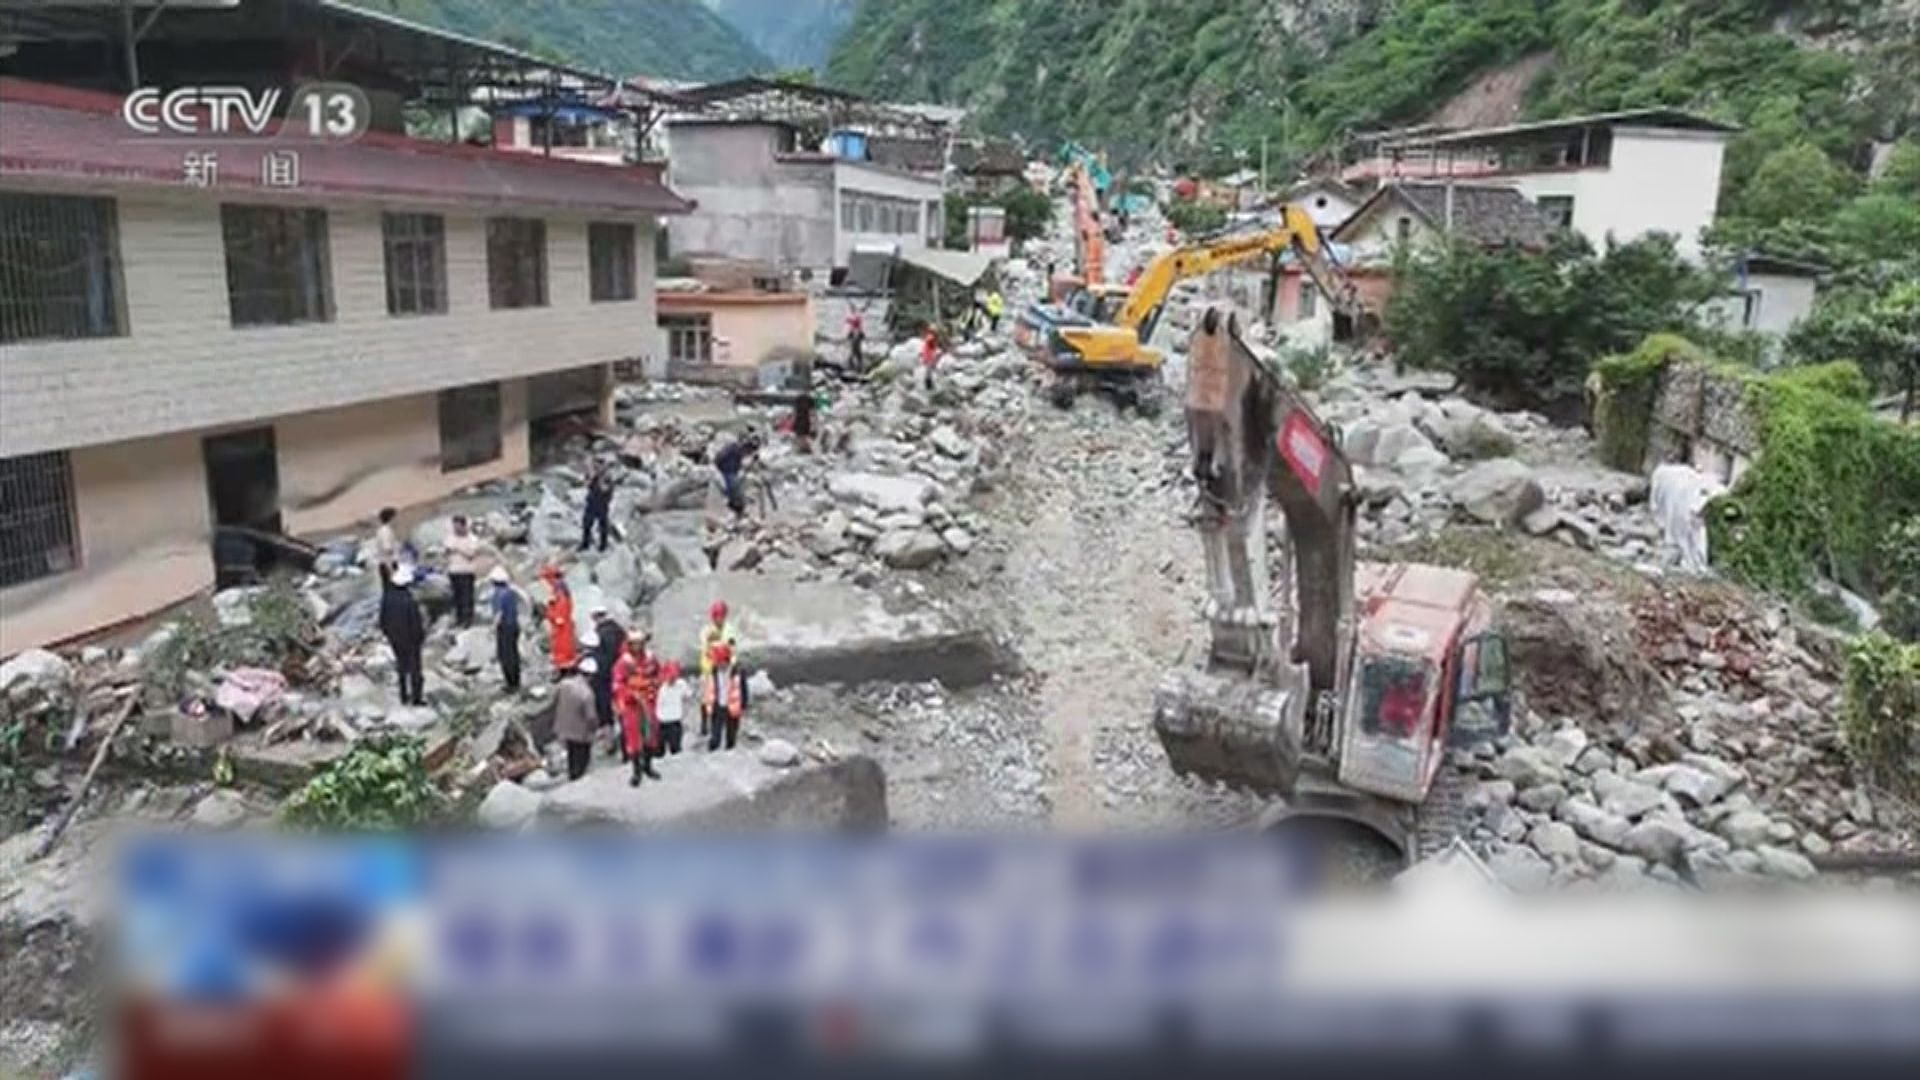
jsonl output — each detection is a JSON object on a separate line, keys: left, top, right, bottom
{"left": 828, "top": 0, "right": 1920, "bottom": 186}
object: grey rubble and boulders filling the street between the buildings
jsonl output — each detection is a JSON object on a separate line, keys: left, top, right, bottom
{"left": 0, "top": 195, "right": 1916, "bottom": 1061}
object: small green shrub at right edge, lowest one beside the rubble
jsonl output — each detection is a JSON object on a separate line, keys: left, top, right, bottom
{"left": 1841, "top": 632, "right": 1920, "bottom": 798}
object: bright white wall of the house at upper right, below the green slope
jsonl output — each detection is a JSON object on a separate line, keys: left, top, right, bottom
{"left": 1500, "top": 127, "right": 1726, "bottom": 259}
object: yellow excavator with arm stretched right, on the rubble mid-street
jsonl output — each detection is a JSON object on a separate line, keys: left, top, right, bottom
{"left": 1014, "top": 204, "right": 1359, "bottom": 415}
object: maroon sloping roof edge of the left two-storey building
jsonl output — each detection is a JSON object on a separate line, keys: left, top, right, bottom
{"left": 0, "top": 79, "right": 693, "bottom": 213}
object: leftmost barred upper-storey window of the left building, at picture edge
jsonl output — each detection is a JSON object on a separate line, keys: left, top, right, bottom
{"left": 0, "top": 192, "right": 127, "bottom": 342}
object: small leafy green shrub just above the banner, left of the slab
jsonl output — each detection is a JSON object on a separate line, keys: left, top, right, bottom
{"left": 280, "top": 736, "right": 445, "bottom": 832}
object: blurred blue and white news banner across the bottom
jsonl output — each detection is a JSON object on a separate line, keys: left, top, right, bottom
{"left": 113, "top": 836, "right": 1920, "bottom": 1078}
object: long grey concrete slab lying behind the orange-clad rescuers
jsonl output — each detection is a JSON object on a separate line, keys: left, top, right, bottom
{"left": 653, "top": 573, "right": 1014, "bottom": 688}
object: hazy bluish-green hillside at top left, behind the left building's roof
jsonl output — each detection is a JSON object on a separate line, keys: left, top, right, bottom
{"left": 353, "top": 0, "right": 772, "bottom": 79}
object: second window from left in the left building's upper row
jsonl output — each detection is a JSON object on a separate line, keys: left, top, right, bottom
{"left": 221, "top": 206, "right": 334, "bottom": 327}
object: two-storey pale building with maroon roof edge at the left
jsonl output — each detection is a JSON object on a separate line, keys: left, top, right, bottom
{"left": 0, "top": 79, "right": 685, "bottom": 653}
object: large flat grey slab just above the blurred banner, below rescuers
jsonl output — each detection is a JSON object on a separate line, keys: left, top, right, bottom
{"left": 538, "top": 748, "right": 887, "bottom": 830}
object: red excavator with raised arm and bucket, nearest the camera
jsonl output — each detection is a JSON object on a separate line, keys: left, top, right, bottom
{"left": 1154, "top": 309, "right": 1511, "bottom": 859}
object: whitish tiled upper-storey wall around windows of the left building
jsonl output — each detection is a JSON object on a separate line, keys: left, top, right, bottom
{"left": 0, "top": 184, "right": 659, "bottom": 455}
